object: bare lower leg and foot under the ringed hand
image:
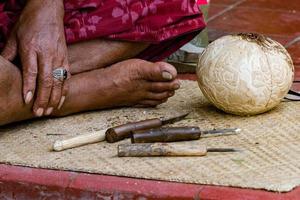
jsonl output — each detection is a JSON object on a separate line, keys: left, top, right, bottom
{"left": 0, "top": 57, "right": 179, "bottom": 125}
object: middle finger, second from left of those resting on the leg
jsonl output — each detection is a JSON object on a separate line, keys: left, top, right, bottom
{"left": 33, "top": 55, "right": 53, "bottom": 117}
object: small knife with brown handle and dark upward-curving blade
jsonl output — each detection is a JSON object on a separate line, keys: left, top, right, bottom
{"left": 105, "top": 113, "right": 189, "bottom": 143}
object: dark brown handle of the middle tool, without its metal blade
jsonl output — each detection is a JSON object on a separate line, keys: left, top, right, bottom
{"left": 131, "top": 126, "right": 201, "bottom": 143}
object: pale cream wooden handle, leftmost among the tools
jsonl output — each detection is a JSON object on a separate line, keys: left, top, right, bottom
{"left": 53, "top": 130, "right": 106, "bottom": 151}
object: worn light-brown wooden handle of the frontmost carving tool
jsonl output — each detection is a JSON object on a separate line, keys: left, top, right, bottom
{"left": 118, "top": 143, "right": 207, "bottom": 157}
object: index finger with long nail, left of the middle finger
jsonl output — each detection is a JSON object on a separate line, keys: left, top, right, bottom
{"left": 20, "top": 48, "right": 38, "bottom": 104}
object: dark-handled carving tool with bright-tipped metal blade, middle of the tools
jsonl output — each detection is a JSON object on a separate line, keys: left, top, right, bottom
{"left": 131, "top": 126, "right": 241, "bottom": 143}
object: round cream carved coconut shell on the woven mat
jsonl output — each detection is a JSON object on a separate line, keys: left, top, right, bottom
{"left": 197, "top": 33, "right": 294, "bottom": 115}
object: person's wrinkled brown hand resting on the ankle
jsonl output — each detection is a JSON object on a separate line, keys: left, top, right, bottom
{"left": 2, "top": 0, "right": 69, "bottom": 117}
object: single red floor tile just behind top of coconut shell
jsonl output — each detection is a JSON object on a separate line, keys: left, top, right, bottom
{"left": 208, "top": 6, "right": 300, "bottom": 39}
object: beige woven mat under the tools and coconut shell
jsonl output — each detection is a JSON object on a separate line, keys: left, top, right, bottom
{"left": 0, "top": 81, "right": 300, "bottom": 192}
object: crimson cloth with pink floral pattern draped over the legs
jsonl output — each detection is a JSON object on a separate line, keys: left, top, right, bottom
{"left": 0, "top": 0, "right": 205, "bottom": 61}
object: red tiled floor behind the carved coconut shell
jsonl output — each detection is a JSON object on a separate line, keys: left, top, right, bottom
{"left": 181, "top": 0, "right": 300, "bottom": 90}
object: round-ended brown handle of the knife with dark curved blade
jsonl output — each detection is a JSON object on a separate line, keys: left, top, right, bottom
{"left": 106, "top": 118, "right": 162, "bottom": 143}
